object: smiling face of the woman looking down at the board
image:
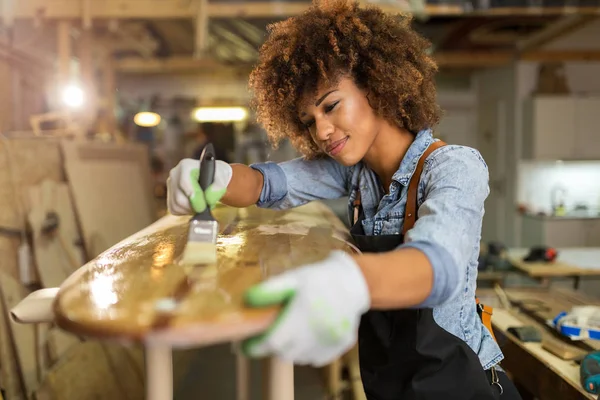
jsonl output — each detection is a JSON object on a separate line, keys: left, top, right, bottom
{"left": 298, "top": 77, "right": 381, "bottom": 166}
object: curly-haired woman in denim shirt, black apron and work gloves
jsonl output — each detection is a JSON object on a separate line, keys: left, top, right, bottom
{"left": 169, "top": 1, "right": 519, "bottom": 400}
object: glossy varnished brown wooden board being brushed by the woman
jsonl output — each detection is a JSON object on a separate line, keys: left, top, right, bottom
{"left": 54, "top": 203, "right": 354, "bottom": 346}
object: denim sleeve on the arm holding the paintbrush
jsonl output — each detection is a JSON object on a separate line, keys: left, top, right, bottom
{"left": 250, "top": 157, "right": 350, "bottom": 210}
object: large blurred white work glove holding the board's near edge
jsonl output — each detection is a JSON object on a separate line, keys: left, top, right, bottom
{"left": 242, "top": 250, "right": 371, "bottom": 367}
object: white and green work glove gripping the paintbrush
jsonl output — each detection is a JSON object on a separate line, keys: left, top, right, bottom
{"left": 167, "top": 158, "right": 233, "bottom": 215}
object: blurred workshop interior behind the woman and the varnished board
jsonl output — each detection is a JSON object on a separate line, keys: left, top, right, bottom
{"left": 0, "top": 0, "right": 600, "bottom": 400}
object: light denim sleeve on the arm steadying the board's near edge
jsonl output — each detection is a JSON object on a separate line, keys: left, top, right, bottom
{"left": 400, "top": 146, "right": 489, "bottom": 307}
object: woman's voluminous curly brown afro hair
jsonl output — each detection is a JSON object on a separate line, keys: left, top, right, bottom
{"left": 249, "top": 0, "right": 441, "bottom": 158}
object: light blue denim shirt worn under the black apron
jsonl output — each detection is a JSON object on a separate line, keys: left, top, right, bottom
{"left": 251, "top": 130, "right": 503, "bottom": 370}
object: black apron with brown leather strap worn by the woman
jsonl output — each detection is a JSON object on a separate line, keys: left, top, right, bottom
{"left": 350, "top": 142, "right": 498, "bottom": 400}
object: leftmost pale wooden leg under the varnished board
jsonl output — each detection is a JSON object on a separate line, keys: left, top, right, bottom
{"left": 146, "top": 345, "right": 173, "bottom": 400}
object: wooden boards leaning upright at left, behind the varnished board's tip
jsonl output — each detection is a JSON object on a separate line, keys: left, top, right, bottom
{"left": 0, "top": 136, "right": 171, "bottom": 400}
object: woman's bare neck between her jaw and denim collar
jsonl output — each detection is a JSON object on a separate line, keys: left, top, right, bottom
{"left": 364, "top": 122, "right": 414, "bottom": 193}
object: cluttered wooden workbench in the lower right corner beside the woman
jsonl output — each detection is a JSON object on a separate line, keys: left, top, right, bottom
{"left": 477, "top": 288, "right": 600, "bottom": 400}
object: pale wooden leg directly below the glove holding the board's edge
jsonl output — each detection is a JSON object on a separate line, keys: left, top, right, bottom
{"left": 263, "top": 357, "right": 294, "bottom": 400}
